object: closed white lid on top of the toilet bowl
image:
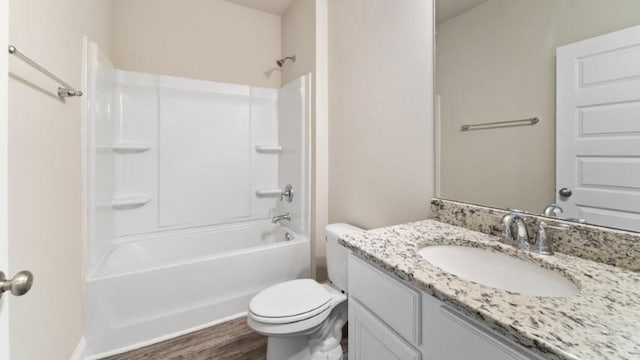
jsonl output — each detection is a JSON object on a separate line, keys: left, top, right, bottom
{"left": 249, "top": 279, "right": 331, "bottom": 318}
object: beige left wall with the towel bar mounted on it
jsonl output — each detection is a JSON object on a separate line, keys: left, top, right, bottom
{"left": 9, "top": 0, "right": 111, "bottom": 360}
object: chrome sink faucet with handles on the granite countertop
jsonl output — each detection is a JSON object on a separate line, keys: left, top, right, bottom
{"left": 502, "top": 213, "right": 569, "bottom": 255}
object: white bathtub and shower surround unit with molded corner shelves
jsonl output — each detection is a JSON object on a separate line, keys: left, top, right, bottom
{"left": 84, "top": 42, "right": 310, "bottom": 358}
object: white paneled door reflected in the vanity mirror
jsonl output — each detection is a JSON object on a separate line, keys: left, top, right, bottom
{"left": 556, "top": 26, "right": 640, "bottom": 231}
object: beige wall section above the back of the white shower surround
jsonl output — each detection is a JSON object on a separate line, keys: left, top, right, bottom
{"left": 112, "top": 0, "right": 281, "bottom": 88}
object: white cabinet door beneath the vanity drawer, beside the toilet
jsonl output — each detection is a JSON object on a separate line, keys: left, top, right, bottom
{"left": 349, "top": 299, "right": 421, "bottom": 360}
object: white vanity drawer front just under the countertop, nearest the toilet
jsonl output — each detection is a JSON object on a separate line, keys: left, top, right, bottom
{"left": 349, "top": 254, "right": 422, "bottom": 345}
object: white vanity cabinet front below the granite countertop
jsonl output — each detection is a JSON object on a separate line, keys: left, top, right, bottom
{"left": 349, "top": 254, "right": 542, "bottom": 360}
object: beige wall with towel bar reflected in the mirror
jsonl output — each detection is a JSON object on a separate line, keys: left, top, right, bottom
{"left": 436, "top": 0, "right": 640, "bottom": 212}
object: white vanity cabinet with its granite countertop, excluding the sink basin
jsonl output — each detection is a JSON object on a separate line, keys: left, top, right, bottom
{"left": 341, "top": 220, "right": 640, "bottom": 360}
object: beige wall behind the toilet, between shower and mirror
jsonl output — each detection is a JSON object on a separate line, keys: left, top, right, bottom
{"left": 329, "top": 0, "right": 434, "bottom": 228}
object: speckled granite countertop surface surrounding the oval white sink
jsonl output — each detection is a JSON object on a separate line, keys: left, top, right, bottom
{"left": 339, "top": 220, "right": 640, "bottom": 360}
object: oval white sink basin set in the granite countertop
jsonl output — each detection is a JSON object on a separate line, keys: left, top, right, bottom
{"left": 418, "top": 245, "right": 579, "bottom": 297}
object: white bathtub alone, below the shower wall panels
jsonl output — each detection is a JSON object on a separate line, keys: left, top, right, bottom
{"left": 85, "top": 221, "right": 310, "bottom": 358}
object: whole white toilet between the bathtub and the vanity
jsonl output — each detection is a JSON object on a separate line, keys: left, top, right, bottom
{"left": 247, "top": 224, "right": 363, "bottom": 360}
